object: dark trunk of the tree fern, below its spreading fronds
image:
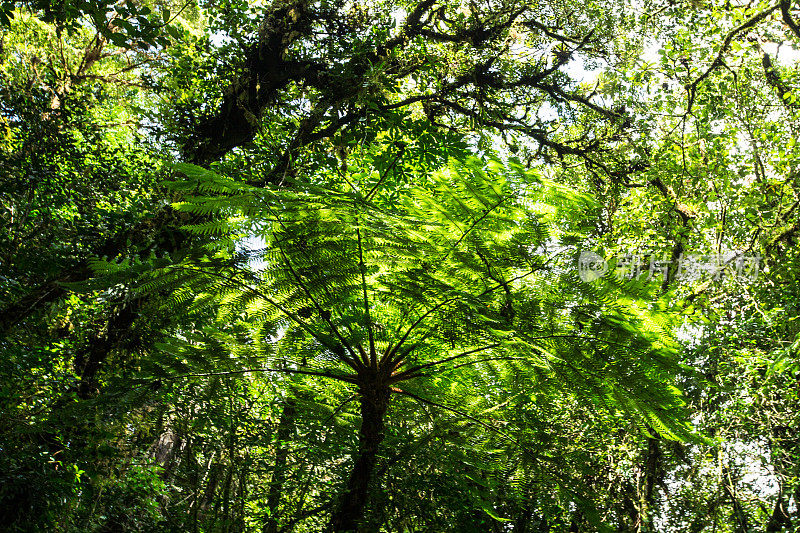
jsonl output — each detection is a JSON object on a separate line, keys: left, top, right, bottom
{"left": 329, "top": 382, "right": 389, "bottom": 532}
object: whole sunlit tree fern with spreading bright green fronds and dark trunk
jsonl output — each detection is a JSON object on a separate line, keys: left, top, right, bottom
{"left": 87, "top": 151, "right": 690, "bottom": 530}
